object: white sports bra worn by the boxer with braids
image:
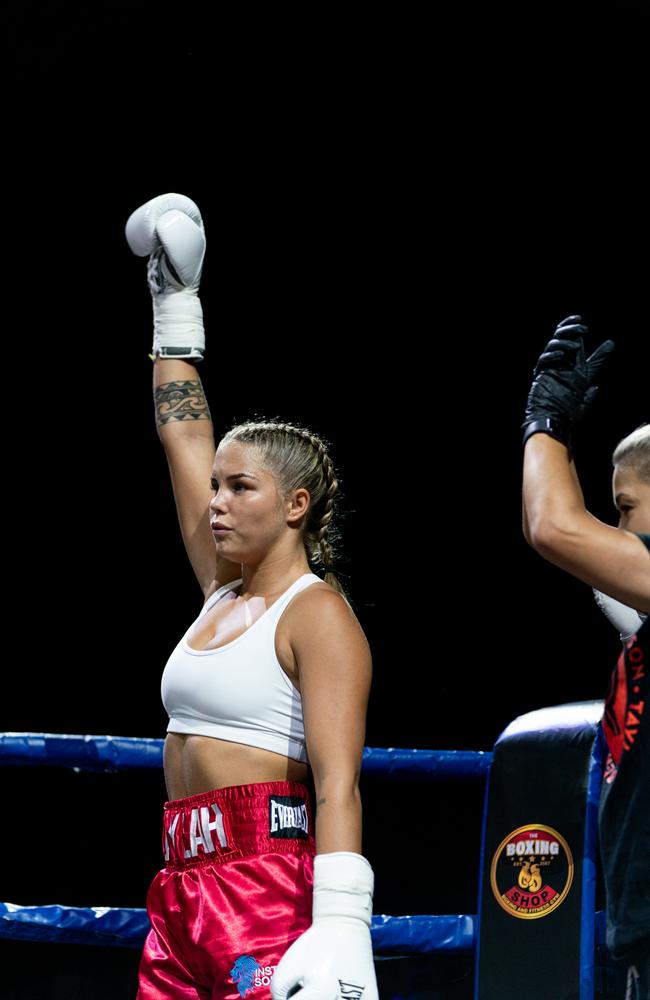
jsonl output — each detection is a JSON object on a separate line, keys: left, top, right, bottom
{"left": 161, "top": 573, "right": 323, "bottom": 762}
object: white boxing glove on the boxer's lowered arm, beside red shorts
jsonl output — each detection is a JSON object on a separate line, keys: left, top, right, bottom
{"left": 271, "top": 851, "right": 379, "bottom": 1000}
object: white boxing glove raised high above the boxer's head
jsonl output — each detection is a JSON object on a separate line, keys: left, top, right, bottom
{"left": 126, "top": 193, "right": 205, "bottom": 362}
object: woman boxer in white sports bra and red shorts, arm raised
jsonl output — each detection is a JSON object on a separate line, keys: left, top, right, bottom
{"left": 126, "top": 194, "right": 377, "bottom": 1000}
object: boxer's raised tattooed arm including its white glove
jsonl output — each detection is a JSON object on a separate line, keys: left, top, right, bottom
{"left": 126, "top": 193, "right": 241, "bottom": 598}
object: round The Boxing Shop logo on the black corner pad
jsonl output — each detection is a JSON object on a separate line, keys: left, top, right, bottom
{"left": 490, "top": 823, "right": 573, "bottom": 920}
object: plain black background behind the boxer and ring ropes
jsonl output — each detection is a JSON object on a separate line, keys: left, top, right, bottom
{"left": 0, "top": 3, "right": 650, "bottom": 996}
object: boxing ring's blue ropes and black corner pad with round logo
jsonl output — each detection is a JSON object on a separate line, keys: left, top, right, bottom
{"left": 0, "top": 702, "right": 617, "bottom": 1000}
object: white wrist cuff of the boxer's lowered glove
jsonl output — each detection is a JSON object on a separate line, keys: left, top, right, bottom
{"left": 312, "top": 851, "right": 375, "bottom": 927}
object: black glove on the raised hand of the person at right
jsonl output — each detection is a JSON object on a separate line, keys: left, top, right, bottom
{"left": 522, "top": 316, "right": 614, "bottom": 448}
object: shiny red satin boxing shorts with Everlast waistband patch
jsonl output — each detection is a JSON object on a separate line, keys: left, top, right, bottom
{"left": 136, "top": 781, "right": 316, "bottom": 1000}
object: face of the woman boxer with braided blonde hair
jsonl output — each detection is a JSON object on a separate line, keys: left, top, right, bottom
{"left": 210, "top": 441, "right": 286, "bottom": 563}
